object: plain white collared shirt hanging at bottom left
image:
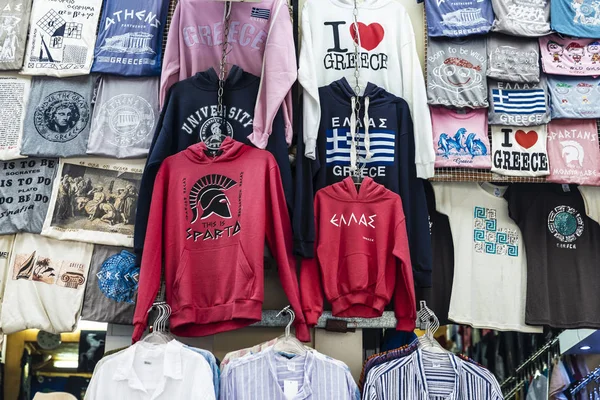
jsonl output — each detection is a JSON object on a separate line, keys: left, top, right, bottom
{"left": 85, "top": 340, "right": 216, "bottom": 400}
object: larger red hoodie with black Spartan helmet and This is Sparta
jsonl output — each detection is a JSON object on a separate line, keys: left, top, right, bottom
{"left": 133, "top": 137, "right": 310, "bottom": 341}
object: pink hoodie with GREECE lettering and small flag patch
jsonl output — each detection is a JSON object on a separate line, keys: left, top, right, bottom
{"left": 160, "top": 0, "right": 297, "bottom": 149}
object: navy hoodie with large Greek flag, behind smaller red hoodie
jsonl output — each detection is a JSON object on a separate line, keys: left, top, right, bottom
{"left": 293, "top": 78, "right": 432, "bottom": 287}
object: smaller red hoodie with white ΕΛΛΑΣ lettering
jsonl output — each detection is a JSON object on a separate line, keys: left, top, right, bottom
{"left": 300, "top": 177, "right": 416, "bottom": 331}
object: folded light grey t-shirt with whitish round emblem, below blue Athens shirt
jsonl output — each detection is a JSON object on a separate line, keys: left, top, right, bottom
{"left": 87, "top": 75, "right": 160, "bottom": 158}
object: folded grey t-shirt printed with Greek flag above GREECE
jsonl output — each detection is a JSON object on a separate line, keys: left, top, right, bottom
{"left": 488, "top": 76, "right": 550, "bottom": 126}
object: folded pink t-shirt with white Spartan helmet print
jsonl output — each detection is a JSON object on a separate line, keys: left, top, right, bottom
{"left": 547, "top": 119, "right": 600, "bottom": 185}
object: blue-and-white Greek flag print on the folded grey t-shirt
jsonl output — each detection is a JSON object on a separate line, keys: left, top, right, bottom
{"left": 492, "top": 89, "right": 546, "bottom": 114}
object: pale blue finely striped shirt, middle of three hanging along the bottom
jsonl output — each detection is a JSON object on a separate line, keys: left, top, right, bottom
{"left": 220, "top": 348, "right": 360, "bottom": 400}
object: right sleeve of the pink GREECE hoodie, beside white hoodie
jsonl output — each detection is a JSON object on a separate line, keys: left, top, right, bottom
{"left": 248, "top": 0, "right": 298, "bottom": 149}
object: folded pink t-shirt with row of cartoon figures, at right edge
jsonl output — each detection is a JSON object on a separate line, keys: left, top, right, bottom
{"left": 539, "top": 34, "right": 600, "bottom": 76}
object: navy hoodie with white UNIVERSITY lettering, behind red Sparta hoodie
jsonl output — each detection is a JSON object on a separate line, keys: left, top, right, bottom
{"left": 133, "top": 66, "right": 293, "bottom": 264}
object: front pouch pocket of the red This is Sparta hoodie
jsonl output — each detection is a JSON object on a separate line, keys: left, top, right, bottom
{"left": 174, "top": 244, "right": 254, "bottom": 308}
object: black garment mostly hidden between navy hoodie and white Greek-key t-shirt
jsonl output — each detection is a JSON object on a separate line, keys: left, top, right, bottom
{"left": 415, "top": 181, "right": 454, "bottom": 325}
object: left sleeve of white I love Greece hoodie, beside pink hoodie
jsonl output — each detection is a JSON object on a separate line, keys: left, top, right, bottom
{"left": 298, "top": 2, "right": 321, "bottom": 160}
